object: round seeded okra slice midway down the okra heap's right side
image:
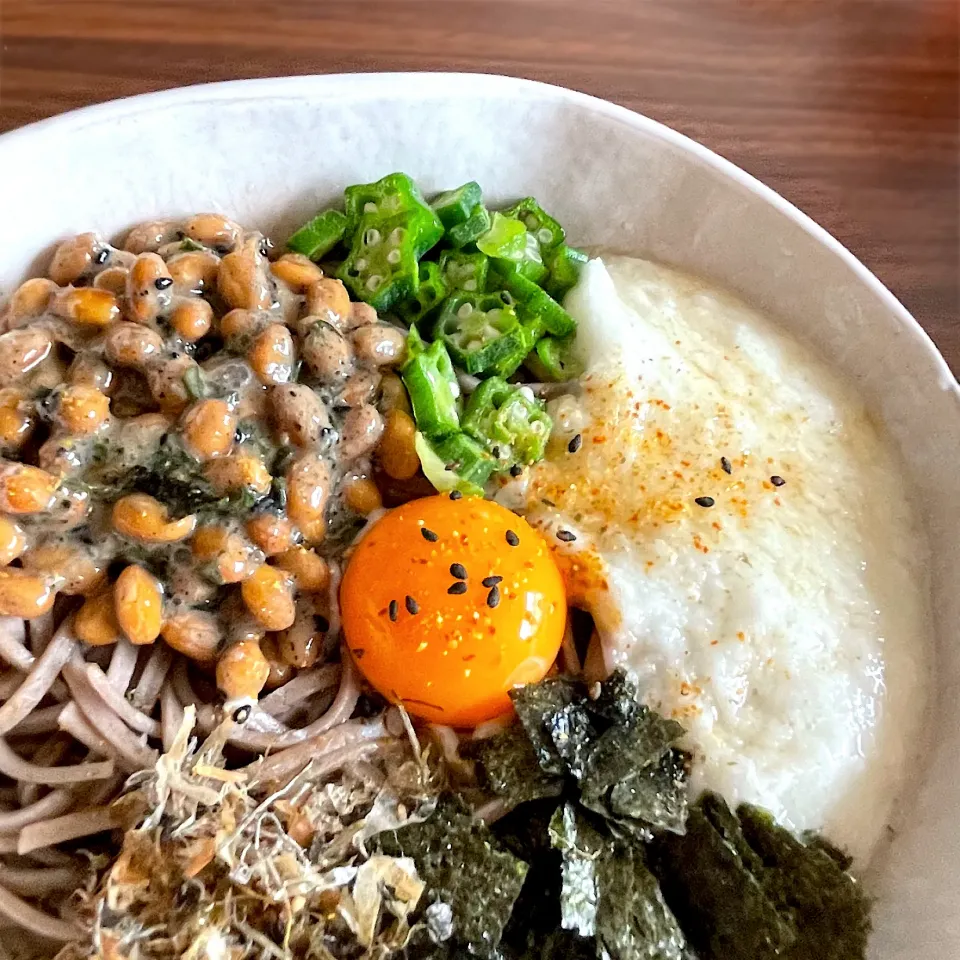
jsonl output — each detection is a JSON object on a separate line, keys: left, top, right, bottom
{"left": 434, "top": 293, "right": 536, "bottom": 377}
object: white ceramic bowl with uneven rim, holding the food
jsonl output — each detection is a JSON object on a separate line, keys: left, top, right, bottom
{"left": 0, "top": 74, "right": 960, "bottom": 960}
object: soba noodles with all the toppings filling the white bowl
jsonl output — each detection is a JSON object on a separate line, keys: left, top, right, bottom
{"left": 0, "top": 75, "right": 950, "bottom": 960}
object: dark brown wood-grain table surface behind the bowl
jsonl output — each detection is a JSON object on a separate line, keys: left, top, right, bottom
{"left": 0, "top": 0, "right": 960, "bottom": 371}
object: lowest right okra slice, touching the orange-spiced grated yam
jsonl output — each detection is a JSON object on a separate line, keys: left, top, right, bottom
{"left": 463, "top": 377, "right": 553, "bottom": 463}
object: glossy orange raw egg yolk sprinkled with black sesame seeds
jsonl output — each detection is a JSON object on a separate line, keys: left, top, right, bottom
{"left": 340, "top": 496, "right": 567, "bottom": 727}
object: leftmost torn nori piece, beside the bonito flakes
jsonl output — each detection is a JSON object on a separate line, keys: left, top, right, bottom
{"left": 380, "top": 797, "right": 528, "bottom": 957}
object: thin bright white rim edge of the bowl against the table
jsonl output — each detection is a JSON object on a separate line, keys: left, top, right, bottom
{"left": 0, "top": 70, "right": 960, "bottom": 397}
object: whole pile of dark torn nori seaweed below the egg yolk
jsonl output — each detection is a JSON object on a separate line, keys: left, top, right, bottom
{"left": 408, "top": 673, "right": 869, "bottom": 960}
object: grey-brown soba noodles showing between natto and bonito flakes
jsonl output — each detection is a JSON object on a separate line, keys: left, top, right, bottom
{"left": 0, "top": 588, "right": 372, "bottom": 942}
